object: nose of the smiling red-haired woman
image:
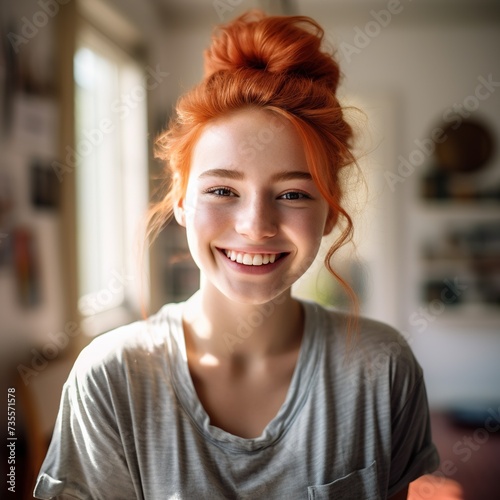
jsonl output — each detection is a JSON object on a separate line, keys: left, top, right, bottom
{"left": 235, "top": 196, "right": 278, "bottom": 241}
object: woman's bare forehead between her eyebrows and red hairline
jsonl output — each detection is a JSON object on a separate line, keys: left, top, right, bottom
{"left": 191, "top": 109, "right": 309, "bottom": 176}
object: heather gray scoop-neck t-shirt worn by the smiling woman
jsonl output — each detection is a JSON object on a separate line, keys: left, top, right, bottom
{"left": 35, "top": 302, "right": 439, "bottom": 500}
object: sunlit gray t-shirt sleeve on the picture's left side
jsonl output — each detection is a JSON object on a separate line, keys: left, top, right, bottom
{"left": 34, "top": 346, "right": 140, "bottom": 500}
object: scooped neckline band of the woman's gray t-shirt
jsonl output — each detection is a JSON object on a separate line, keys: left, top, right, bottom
{"left": 165, "top": 300, "right": 324, "bottom": 451}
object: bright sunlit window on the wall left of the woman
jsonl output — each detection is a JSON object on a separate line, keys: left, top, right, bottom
{"left": 74, "top": 24, "right": 148, "bottom": 335}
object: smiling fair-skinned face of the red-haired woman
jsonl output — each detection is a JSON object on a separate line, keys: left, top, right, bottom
{"left": 174, "top": 109, "right": 333, "bottom": 304}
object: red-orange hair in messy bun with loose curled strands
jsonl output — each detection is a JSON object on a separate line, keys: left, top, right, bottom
{"left": 148, "top": 11, "right": 357, "bottom": 318}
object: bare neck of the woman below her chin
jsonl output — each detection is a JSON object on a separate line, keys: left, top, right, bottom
{"left": 183, "top": 284, "right": 303, "bottom": 361}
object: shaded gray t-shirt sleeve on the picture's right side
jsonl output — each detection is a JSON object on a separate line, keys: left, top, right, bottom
{"left": 388, "top": 353, "right": 439, "bottom": 497}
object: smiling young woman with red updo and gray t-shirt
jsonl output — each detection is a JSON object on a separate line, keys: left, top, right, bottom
{"left": 35, "top": 8, "right": 438, "bottom": 500}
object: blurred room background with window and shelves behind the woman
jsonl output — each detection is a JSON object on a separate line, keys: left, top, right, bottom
{"left": 0, "top": 0, "right": 500, "bottom": 500}
